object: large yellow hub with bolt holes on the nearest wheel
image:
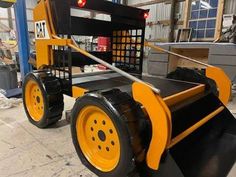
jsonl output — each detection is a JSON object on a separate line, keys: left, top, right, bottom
{"left": 76, "top": 106, "right": 120, "bottom": 172}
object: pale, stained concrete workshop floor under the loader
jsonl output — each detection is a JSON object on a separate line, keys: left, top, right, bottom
{"left": 0, "top": 92, "right": 236, "bottom": 177}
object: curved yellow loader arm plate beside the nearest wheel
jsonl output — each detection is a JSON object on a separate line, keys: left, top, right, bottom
{"left": 132, "top": 82, "right": 172, "bottom": 170}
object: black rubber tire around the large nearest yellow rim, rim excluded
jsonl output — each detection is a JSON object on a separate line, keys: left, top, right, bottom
{"left": 71, "top": 89, "right": 144, "bottom": 177}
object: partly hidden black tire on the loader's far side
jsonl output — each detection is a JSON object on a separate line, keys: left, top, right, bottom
{"left": 167, "top": 67, "right": 219, "bottom": 96}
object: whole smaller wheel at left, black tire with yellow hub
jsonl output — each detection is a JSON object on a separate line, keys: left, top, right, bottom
{"left": 23, "top": 72, "right": 64, "bottom": 128}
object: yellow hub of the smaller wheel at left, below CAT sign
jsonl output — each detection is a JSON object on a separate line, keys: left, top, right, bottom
{"left": 25, "top": 80, "right": 44, "bottom": 121}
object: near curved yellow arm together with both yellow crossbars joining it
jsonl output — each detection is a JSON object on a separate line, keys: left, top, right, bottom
{"left": 132, "top": 82, "right": 224, "bottom": 170}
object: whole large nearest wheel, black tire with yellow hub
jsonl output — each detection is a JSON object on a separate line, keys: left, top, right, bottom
{"left": 71, "top": 90, "right": 143, "bottom": 177}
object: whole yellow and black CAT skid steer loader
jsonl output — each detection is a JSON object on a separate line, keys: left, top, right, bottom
{"left": 23, "top": 0, "right": 236, "bottom": 177}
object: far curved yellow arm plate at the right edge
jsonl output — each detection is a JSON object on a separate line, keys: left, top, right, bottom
{"left": 206, "top": 66, "right": 232, "bottom": 105}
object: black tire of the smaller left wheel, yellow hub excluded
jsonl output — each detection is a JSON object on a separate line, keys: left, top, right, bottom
{"left": 23, "top": 71, "right": 64, "bottom": 128}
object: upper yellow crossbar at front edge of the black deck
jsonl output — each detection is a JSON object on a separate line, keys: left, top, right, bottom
{"left": 163, "top": 84, "right": 205, "bottom": 106}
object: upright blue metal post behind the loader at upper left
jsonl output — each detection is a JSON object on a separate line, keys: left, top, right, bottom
{"left": 14, "top": 0, "right": 32, "bottom": 79}
